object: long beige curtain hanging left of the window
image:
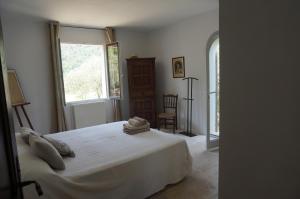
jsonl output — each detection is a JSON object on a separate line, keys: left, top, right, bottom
{"left": 50, "top": 22, "right": 67, "bottom": 131}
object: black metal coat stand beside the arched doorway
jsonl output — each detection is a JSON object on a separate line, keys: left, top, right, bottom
{"left": 182, "top": 77, "right": 199, "bottom": 137}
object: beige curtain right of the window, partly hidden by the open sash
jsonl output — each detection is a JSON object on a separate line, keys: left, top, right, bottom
{"left": 105, "top": 27, "right": 122, "bottom": 122}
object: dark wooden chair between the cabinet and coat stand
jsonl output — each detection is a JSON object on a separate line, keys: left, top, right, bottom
{"left": 157, "top": 94, "right": 178, "bottom": 133}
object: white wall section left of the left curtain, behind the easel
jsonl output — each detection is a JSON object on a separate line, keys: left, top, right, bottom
{"left": 1, "top": 11, "right": 56, "bottom": 133}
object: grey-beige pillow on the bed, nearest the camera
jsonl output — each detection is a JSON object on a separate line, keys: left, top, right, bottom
{"left": 29, "top": 134, "right": 65, "bottom": 170}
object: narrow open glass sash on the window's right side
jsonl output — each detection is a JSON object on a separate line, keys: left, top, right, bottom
{"left": 106, "top": 43, "right": 121, "bottom": 97}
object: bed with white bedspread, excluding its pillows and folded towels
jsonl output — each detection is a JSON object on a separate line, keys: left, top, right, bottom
{"left": 16, "top": 121, "right": 192, "bottom": 199}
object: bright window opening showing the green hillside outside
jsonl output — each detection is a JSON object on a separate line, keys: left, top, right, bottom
{"left": 61, "top": 42, "right": 107, "bottom": 103}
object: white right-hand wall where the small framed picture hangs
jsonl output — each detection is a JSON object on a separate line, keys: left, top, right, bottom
{"left": 148, "top": 10, "right": 219, "bottom": 134}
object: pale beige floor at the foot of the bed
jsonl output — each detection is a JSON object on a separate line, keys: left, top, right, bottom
{"left": 148, "top": 135, "right": 219, "bottom": 199}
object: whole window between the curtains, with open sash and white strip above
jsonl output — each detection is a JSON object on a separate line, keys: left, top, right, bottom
{"left": 59, "top": 26, "right": 121, "bottom": 103}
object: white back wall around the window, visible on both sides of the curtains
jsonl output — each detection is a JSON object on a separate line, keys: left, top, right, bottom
{"left": 1, "top": 10, "right": 146, "bottom": 133}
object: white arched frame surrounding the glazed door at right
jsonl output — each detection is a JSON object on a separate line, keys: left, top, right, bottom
{"left": 206, "top": 31, "right": 219, "bottom": 149}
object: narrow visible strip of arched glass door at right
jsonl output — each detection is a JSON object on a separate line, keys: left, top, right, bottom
{"left": 207, "top": 33, "right": 220, "bottom": 137}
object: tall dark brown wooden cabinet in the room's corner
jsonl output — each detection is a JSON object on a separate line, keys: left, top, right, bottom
{"left": 127, "top": 58, "right": 156, "bottom": 127}
